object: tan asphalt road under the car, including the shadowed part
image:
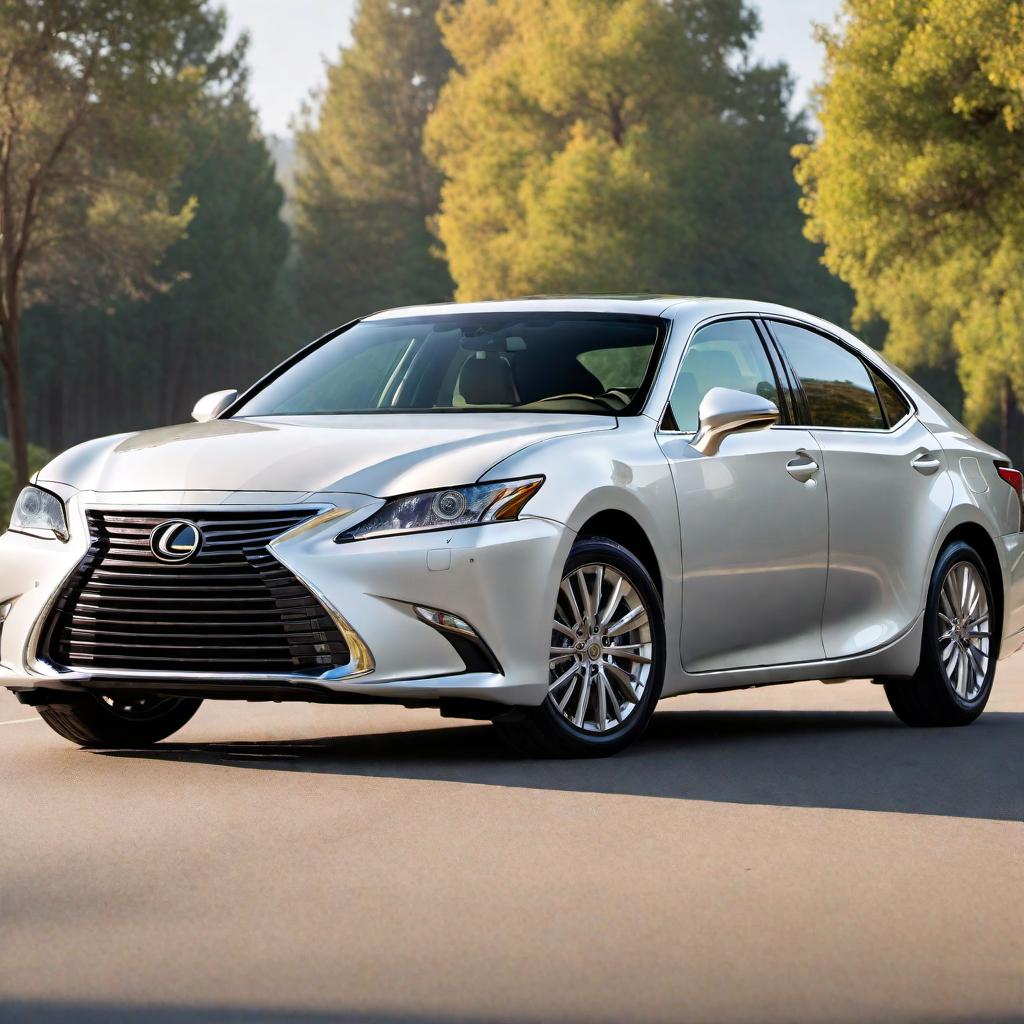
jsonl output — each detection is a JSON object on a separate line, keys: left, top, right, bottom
{"left": 0, "top": 656, "right": 1024, "bottom": 1024}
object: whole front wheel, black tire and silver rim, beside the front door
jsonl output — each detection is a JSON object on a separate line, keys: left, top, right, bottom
{"left": 495, "top": 538, "right": 665, "bottom": 758}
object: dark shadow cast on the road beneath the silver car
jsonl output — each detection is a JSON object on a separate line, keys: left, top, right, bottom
{"left": 100, "top": 710, "right": 1024, "bottom": 821}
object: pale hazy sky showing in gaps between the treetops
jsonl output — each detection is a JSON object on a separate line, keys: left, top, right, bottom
{"left": 221, "top": 0, "right": 840, "bottom": 135}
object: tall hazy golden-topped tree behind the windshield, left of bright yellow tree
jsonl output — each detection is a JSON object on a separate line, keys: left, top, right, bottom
{"left": 295, "top": 0, "right": 452, "bottom": 329}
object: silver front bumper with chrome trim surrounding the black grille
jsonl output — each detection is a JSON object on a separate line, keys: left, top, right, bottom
{"left": 0, "top": 493, "right": 572, "bottom": 706}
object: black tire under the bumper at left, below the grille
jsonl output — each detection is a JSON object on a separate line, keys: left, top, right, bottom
{"left": 38, "top": 693, "right": 203, "bottom": 748}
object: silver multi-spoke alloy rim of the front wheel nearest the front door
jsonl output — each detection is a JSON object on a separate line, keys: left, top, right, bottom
{"left": 548, "top": 563, "right": 654, "bottom": 733}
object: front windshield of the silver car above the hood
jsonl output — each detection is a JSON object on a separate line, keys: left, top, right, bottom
{"left": 234, "top": 313, "right": 662, "bottom": 416}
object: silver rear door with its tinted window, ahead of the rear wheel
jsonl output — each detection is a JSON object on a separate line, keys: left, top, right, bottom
{"left": 767, "top": 321, "right": 952, "bottom": 658}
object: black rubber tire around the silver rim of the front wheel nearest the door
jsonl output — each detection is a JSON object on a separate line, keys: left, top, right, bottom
{"left": 534, "top": 538, "right": 666, "bottom": 756}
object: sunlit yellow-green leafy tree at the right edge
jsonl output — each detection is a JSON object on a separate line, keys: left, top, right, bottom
{"left": 798, "top": 0, "right": 1024, "bottom": 446}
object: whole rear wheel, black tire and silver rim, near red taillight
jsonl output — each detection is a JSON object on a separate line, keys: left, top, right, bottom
{"left": 885, "top": 541, "right": 999, "bottom": 727}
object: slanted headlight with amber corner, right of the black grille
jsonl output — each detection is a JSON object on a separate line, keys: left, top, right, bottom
{"left": 338, "top": 476, "right": 544, "bottom": 543}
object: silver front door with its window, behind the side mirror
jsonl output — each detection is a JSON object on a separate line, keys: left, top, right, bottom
{"left": 658, "top": 319, "right": 828, "bottom": 673}
